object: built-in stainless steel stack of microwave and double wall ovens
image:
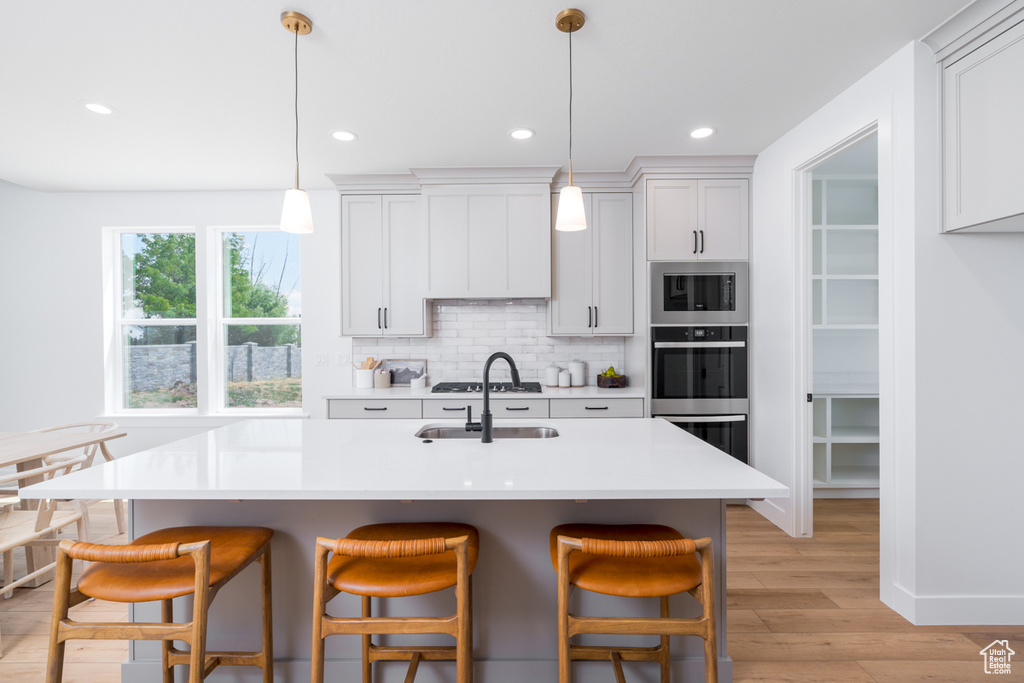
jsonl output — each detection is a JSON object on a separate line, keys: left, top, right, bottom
{"left": 649, "top": 261, "right": 750, "bottom": 463}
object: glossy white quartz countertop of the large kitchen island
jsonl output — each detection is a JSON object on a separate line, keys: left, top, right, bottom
{"left": 20, "top": 418, "right": 790, "bottom": 501}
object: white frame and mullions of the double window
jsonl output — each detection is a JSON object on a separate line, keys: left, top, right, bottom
{"left": 101, "top": 225, "right": 304, "bottom": 418}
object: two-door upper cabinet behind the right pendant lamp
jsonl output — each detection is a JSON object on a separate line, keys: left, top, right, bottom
{"left": 548, "top": 193, "right": 633, "bottom": 336}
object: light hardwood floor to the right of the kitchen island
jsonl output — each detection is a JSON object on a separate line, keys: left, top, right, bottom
{"left": 726, "top": 500, "right": 1024, "bottom": 683}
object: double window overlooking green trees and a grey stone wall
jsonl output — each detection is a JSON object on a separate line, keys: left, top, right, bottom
{"left": 104, "top": 227, "right": 302, "bottom": 414}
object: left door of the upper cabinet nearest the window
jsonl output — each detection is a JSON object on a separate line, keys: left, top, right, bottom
{"left": 341, "top": 196, "right": 384, "bottom": 337}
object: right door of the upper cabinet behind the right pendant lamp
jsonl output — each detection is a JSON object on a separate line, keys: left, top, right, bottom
{"left": 584, "top": 193, "right": 633, "bottom": 335}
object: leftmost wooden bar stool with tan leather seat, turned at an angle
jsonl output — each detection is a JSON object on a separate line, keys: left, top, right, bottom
{"left": 46, "top": 526, "right": 273, "bottom": 683}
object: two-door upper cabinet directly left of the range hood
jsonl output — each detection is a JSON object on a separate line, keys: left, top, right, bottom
{"left": 341, "top": 195, "right": 430, "bottom": 337}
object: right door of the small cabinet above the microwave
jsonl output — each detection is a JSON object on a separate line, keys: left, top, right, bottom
{"left": 697, "top": 179, "right": 750, "bottom": 261}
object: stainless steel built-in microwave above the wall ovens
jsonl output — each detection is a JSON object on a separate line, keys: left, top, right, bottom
{"left": 650, "top": 261, "right": 749, "bottom": 325}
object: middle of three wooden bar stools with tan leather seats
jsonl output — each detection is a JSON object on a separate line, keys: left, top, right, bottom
{"left": 311, "top": 522, "right": 480, "bottom": 683}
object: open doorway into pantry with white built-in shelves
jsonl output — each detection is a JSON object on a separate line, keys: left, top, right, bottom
{"left": 796, "top": 126, "right": 888, "bottom": 536}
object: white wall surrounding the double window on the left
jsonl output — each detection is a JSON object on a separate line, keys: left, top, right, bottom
{"left": 0, "top": 181, "right": 350, "bottom": 455}
